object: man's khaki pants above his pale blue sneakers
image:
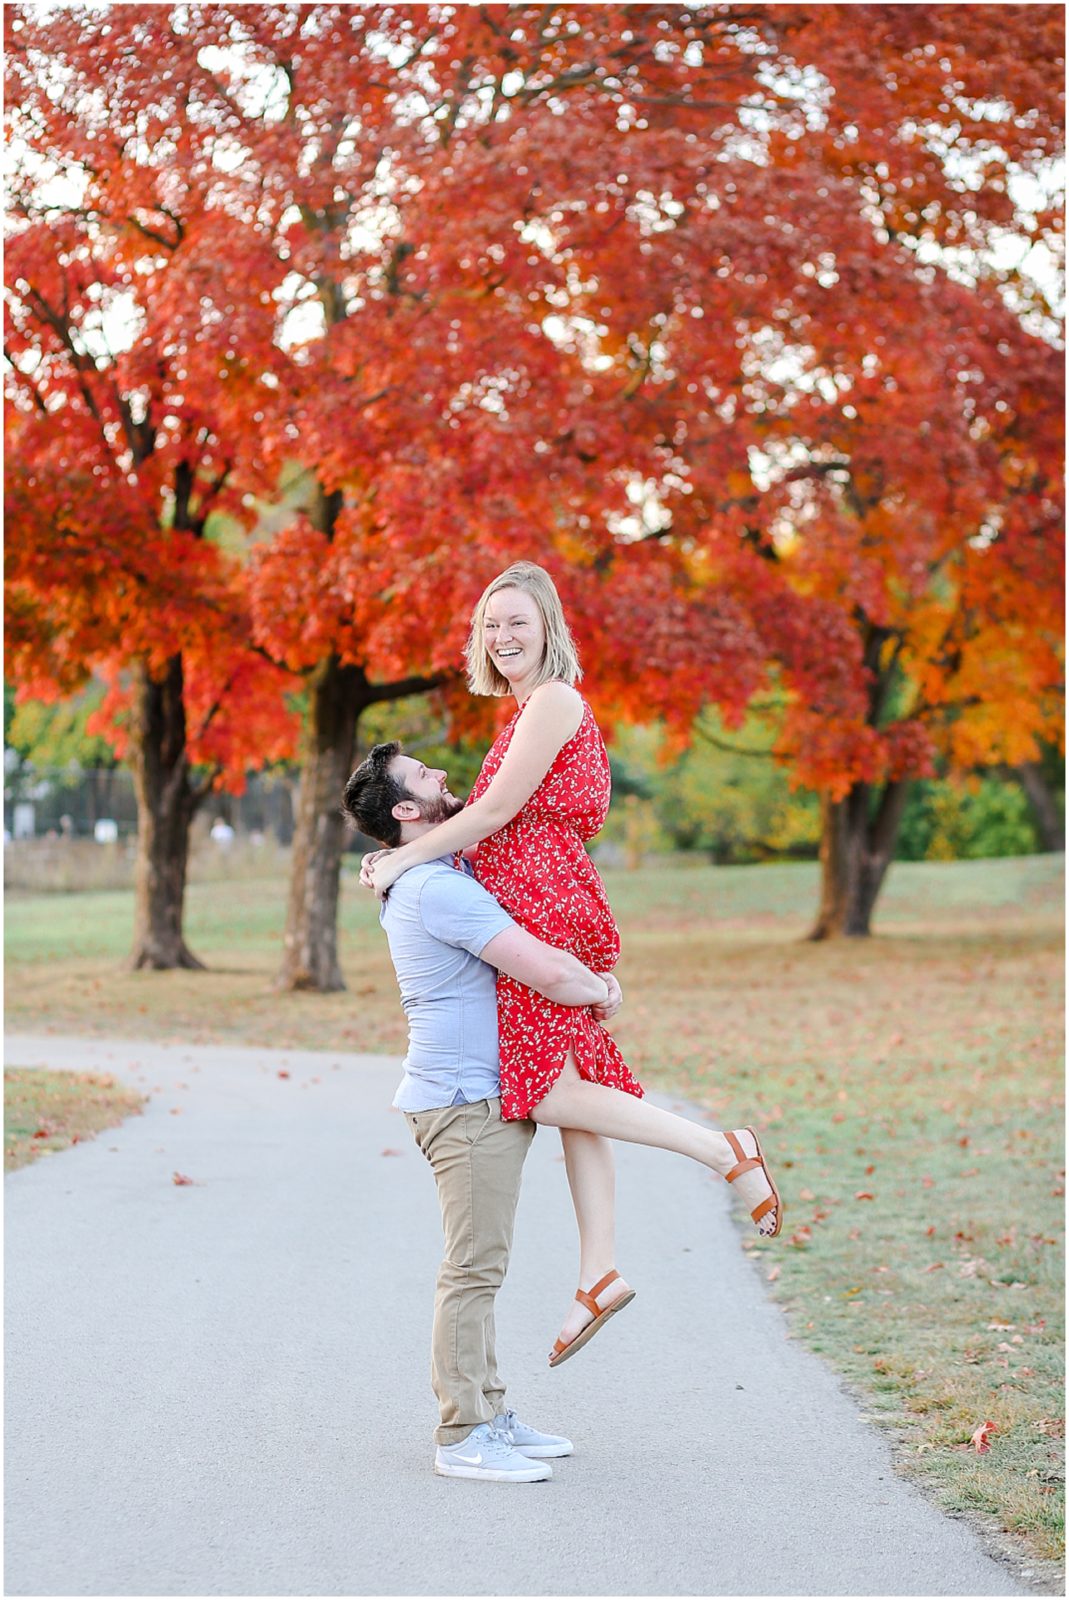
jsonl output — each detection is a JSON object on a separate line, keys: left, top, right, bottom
{"left": 405, "top": 1098, "right": 535, "bottom": 1445}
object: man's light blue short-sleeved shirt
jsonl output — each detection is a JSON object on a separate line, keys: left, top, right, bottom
{"left": 379, "top": 856, "right": 514, "bottom": 1110}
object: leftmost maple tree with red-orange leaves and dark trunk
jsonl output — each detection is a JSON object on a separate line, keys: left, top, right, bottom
{"left": 5, "top": 50, "right": 296, "bottom": 968}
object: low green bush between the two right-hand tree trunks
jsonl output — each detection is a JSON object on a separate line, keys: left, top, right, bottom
{"left": 896, "top": 778, "right": 1040, "bottom": 861}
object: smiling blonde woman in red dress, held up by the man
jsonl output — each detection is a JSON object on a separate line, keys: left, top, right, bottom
{"left": 363, "top": 562, "right": 783, "bottom": 1366}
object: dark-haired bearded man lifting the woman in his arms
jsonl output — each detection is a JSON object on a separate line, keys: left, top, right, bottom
{"left": 342, "top": 742, "right": 621, "bottom": 1483}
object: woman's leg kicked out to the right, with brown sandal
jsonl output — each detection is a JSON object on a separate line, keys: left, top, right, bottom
{"left": 531, "top": 1054, "right": 776, "bottom": 1235}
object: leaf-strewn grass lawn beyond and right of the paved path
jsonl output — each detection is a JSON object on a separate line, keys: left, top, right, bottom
{"left": 8, "top": 858, "right": 1064, "bottom": 1560}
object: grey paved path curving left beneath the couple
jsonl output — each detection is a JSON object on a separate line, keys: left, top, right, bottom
{"left": 6, "top": 1037, "right": 1029, "bottom": 1595}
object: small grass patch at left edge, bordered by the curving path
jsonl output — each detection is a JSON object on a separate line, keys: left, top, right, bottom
{"left": 3, "top": 1067, "right": 144, "bottom": 1173}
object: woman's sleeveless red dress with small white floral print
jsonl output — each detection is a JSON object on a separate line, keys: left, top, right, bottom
{"left": 469, "top": 701, "right": 642, "bottom": 1122}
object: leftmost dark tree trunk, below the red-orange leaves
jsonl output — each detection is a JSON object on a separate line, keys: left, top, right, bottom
{"left": 130, "top": 656, "right": 203, "bottom": 971}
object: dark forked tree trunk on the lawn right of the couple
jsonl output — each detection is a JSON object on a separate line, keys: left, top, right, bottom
{"left": 810, "top": 779, "right": 909, "bottom": 939}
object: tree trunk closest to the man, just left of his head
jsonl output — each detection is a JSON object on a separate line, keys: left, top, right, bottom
{"left": 277, "top": 656, "right": 368, "bottom": 994}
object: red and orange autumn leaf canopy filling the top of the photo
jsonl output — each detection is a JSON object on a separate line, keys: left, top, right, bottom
{"left": 8, "top": 5, "right": 1061, "bottom": 794}
